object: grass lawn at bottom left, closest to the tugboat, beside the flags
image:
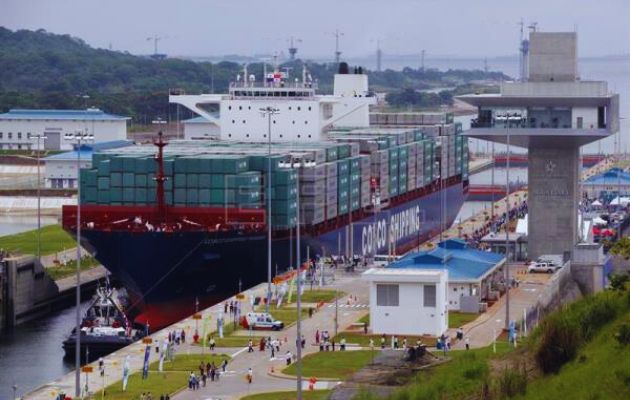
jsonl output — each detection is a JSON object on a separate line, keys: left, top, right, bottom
{"left": 92, "top": 354, "right": 229, "bottom": 400}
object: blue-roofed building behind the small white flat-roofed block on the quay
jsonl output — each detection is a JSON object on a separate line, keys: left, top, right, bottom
{"left": 387, "top": 239, "right": 505, "bottom": 312}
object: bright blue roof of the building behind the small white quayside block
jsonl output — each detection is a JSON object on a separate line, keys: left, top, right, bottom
{"left": 388, "top": 239, "right": 505, "bottom": 282}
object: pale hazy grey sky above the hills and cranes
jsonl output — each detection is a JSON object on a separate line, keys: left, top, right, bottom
{"left": 0, "top": 0, "right": 630, "bottom": 58}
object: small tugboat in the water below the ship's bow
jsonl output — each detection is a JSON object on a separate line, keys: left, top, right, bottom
{"left": 63, "top": 285, "right": 141, "bottom": 361}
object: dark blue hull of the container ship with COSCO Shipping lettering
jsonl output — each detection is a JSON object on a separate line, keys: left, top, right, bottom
{"left": 76, "top": 182, "right": 465, "bottom": 329}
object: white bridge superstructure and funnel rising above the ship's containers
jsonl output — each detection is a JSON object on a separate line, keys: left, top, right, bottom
{"left": 169, "top": 63, "right": 376, "bottom": 142}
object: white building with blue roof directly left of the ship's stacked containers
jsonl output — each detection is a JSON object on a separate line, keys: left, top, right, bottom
{"left": 44, "top": 140, "right": 133, "bottom": 189}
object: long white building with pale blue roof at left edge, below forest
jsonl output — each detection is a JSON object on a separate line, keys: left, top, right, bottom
{"left": 0, "top": 108, "right": 130, "bottom": 150}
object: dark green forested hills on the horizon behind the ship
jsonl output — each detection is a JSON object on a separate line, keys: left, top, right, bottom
{"left": 0, "top": 27, "right": 508, "bottom": 124}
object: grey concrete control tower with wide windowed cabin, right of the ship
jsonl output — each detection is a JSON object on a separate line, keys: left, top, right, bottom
{"left": 458, "top": 32, "right": 619, "bottom": 259}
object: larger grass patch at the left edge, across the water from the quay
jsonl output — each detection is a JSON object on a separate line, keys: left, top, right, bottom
{"left": 0, "top": 225, "right": 77, "bottom": 255}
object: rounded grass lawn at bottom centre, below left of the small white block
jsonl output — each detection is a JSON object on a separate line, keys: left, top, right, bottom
{"left": 282, "top": 350, "right": 378, "bottom": 379}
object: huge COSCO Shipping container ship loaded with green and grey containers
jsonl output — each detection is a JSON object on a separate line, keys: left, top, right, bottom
{"left": 63, "top": 63, "right": 468, "bottom": 328}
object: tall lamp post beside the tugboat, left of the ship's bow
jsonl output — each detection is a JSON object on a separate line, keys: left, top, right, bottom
{"left": 63, "top": 129, "right": 94, "bottom": 398}
